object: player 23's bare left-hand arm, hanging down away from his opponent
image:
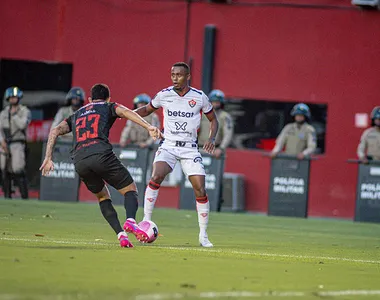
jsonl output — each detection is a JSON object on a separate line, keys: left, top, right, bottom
{"left": 40, "top": 117, "right": 71, "bottom": 176}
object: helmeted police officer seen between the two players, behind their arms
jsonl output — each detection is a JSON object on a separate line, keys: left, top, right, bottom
{"left": 120, "top": 94, "right": 160, "bottom": 148}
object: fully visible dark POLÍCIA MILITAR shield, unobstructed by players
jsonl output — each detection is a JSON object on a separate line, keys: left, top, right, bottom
{"left": 268, "top": 156, "right": 310, "bottom": 218}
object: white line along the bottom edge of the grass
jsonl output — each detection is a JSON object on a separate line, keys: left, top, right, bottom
{"left": 135, "top": 290, "right": 380, "bottom": 300}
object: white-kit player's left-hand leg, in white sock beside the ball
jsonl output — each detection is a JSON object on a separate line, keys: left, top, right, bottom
{"left": 144, "top": 148, "right": 177, "bottom": 221}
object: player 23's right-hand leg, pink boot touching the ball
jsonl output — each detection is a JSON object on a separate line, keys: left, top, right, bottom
{"left": 96, "top": 153, "right": 148, "bottom": 242}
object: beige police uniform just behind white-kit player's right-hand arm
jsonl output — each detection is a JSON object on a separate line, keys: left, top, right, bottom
{"left": 198, "top": 109, "right": 234, "bottom": 150}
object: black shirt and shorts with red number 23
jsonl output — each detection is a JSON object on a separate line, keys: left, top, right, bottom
{"left": 65, "top": 102, "right": 133, "bottom": 193}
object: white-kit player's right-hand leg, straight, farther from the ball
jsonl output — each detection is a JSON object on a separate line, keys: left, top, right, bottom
{"left": 181, "top": 154, "right": 213, "bottom": 247}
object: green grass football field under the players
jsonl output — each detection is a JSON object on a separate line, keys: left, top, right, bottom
{"left": 0, "top": 199, "right": 380, "bottom": 300}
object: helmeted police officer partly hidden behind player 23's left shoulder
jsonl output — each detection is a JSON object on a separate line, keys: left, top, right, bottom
{"left": 51, "top": 87, "right": 85, "bottom": 142}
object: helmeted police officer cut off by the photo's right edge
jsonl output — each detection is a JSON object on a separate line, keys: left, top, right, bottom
{"left": 357, "top": 106, "right": 380, "bottom": 164}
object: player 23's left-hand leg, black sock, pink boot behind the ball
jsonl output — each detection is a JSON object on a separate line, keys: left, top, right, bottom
{"left": 75, "top": 155, "right": 133, "bottom": 248}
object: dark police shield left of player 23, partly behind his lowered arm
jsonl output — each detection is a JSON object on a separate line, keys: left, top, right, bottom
{"left": 40, "top": 142, "right": 80, "bottom": 202}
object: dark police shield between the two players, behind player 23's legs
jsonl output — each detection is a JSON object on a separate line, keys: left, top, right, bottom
{"left": 108, "top": 145, "right": 151, "bottom": 206}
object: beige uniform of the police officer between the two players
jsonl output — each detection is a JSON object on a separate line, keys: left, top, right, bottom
{"left": 120, "top": 113, "right": 160, "bottom": 146}
